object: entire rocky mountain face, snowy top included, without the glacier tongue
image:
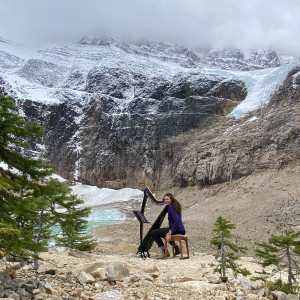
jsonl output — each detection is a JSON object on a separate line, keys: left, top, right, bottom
{"left": 0, "top": 39, "right": 299, "bottom": 189}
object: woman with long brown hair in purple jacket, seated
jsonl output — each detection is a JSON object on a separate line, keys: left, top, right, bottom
{"left": 151, "top": 193, "right": 185, "bottom": 258}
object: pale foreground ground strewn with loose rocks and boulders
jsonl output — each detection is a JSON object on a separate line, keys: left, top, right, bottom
{"left": 0, "top": 243, "right": 299, "bottom": 300}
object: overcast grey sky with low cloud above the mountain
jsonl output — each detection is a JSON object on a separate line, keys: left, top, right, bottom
{"left": 0, "top": 0, "right": 300, "bottom": 54}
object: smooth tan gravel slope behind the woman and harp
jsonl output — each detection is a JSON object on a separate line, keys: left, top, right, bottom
{"left": 93, "top": 165, "right": 300, "bottom": 255}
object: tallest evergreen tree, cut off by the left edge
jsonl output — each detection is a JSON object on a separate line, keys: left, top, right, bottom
{"left": 0, "top": 94, "right": 53, "bottom": 254}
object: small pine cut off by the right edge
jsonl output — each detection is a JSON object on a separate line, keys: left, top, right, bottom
{"left": 255, "top": 230, "right": 300, "bottom": 287}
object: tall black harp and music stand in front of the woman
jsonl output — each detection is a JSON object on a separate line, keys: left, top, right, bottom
{"left": 133, "top": 188, "right": 168, "bottom": 258}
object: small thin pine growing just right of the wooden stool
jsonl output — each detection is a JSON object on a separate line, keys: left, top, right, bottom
{"left": 210, "top": 216, "right": 250, "bottom": 277}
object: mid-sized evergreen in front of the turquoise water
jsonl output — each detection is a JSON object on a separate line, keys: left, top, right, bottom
{"left": 37, "top": 179, "right": 96, "bottom": 251}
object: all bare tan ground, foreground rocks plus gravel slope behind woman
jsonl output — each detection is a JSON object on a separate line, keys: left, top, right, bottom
{"left": 0, "top": 165, "right": 300, "bottom": 300}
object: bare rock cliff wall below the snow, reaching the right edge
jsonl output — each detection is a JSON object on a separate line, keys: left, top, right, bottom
{"left": 18, "top": 63, "right": 300, "bottom": 189}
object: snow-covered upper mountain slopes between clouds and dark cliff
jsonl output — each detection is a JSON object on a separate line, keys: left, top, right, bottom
{"left": 0, "top": 38, "right": 290, "bottom": 103}
